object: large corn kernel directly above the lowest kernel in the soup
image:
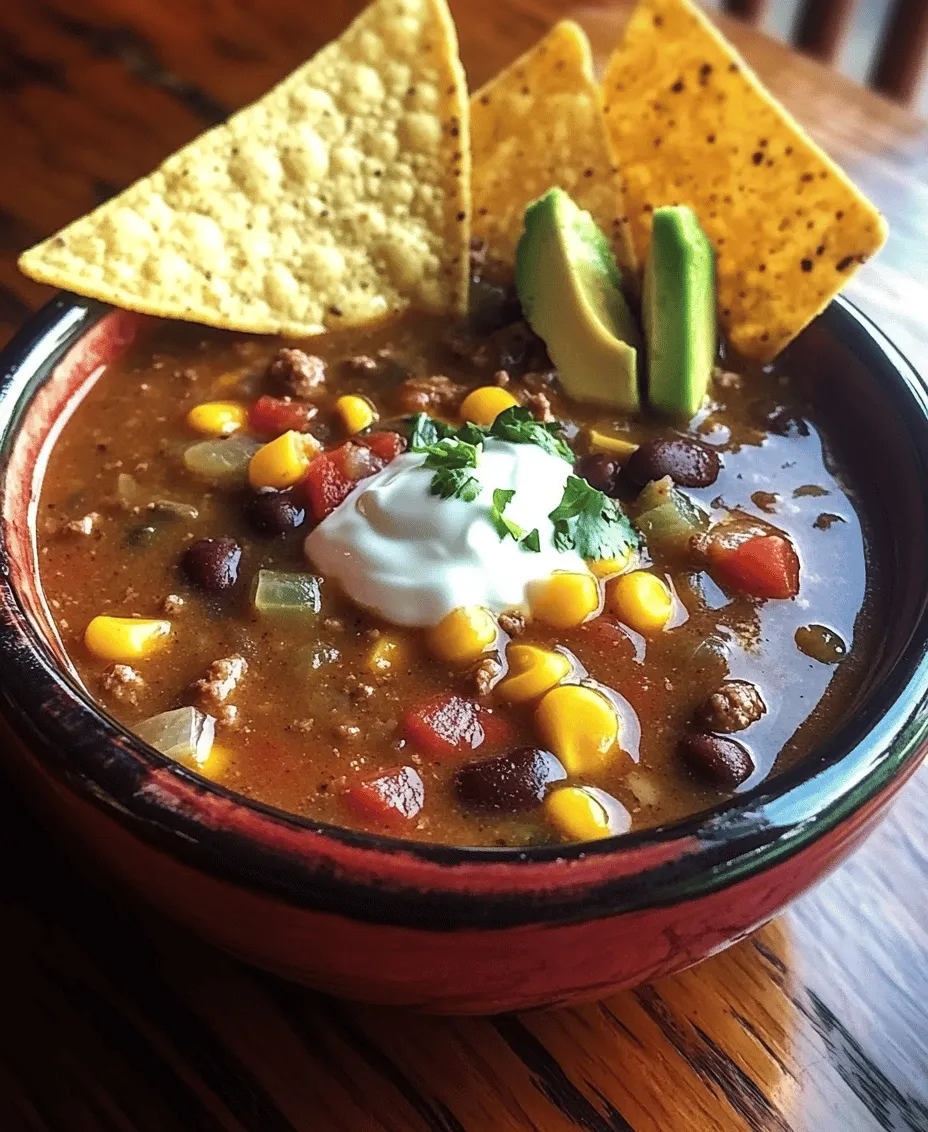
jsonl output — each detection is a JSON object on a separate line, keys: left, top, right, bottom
{"left": 535, "top": 684, "right": 619, "bottom": 774}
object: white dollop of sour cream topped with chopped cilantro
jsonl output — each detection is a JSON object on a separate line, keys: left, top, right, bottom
{"left": 306, "top": 438, "right": 588, "bottom": 627}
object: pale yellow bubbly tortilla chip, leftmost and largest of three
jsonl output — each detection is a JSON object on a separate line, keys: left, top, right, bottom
{"left": 19, "top": 0, "right": 470, "bottom": 336}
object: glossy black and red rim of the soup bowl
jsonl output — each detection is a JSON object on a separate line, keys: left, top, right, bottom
{"left": 0, "top": 292, "right": 928, "bottom": 927}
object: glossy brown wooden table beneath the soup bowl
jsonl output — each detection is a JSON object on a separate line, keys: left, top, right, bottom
{"left": 0, "top": 0, "right": 928, "bottom": 1132}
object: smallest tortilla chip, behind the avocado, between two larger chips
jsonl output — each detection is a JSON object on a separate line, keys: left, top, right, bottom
{"left": 471, "top": 20, "right": 635, "bottom": 267}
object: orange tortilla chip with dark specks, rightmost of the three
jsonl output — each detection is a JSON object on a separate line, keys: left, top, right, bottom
{"left": 603, "top": 0, "right": 886, "bottom": 361}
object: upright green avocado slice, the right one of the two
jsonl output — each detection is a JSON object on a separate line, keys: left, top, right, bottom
{"left": 642, "top": 205, "right": 718, "bottom": 418}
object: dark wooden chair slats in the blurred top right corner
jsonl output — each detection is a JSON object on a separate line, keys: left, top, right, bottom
{"left": 722, "top": 0, "right": 928, "bottom": 102}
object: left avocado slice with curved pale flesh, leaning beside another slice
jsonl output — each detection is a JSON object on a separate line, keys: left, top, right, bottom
{"left": 516, "top": 189, "right": 641, "bottom": 412}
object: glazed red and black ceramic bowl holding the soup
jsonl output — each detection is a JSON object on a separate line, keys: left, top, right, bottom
{"left": 0, "top": 295, "right": 928, "bottom": 1013}
